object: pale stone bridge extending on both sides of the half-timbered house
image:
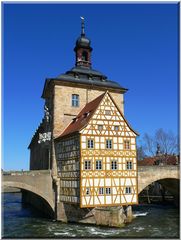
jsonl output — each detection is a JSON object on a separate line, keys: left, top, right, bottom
{"left": 2, "top": 165, "right": 180, "bottom": 216}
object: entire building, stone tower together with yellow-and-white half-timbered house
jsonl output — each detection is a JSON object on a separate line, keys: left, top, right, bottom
{"left": 29, "top": 19, "right": 138, "bottom": 212}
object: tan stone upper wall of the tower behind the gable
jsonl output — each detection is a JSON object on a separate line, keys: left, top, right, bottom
{"left": 53, "top": 85, "right": 124, "bottom": 137}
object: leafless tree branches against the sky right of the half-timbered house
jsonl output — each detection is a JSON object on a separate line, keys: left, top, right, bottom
{"left": 143, "top": 128, "right": 179, "bottom": 156}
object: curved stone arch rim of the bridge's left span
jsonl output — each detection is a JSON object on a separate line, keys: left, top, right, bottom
{"left": 2, "top": 181, "right": 55, "bottom": 217}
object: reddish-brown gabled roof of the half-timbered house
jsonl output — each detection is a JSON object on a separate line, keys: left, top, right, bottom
{"left": 56, "top": 91, "right": 139, "bottom": 140}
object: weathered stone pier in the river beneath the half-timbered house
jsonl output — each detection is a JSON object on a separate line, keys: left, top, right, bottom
{"left": 57, "top": 202, "right": 133, "bottom": 227}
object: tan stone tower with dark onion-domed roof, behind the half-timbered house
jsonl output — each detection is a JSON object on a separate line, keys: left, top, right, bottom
{"left": 29, "top": 18, "right": 127, "bottom": 176}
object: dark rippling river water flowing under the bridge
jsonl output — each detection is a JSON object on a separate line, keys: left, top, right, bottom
{"left": 2, "top": 193, "right": 179, "bottom": 239}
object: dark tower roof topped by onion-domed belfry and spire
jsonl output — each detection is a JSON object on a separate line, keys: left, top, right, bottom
{"left": 42, "top": 17, "right": 128, "bottom": 98}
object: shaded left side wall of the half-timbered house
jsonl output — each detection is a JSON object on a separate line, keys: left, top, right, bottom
{"left": 56, "top": 134, "right": 80, "bottom": 203}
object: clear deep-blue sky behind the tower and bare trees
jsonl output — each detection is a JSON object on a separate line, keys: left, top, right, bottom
{"left": 2, "top": 3, "right": 179, "bottom": 170}
